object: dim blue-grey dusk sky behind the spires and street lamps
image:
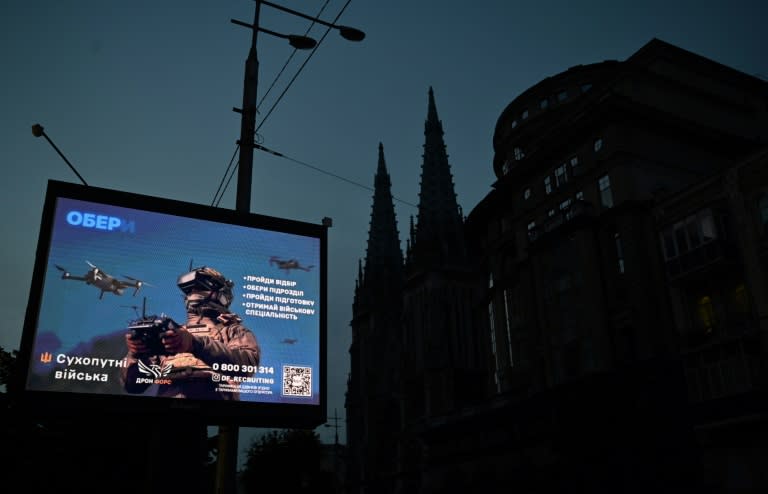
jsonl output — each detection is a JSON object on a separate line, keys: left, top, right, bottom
{"left": 0, "top": 0, "right": 768, "bottom": 464}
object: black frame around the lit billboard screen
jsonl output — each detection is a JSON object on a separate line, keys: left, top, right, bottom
{"left": 14, "top": 180, "right": 328, "bottom": 428}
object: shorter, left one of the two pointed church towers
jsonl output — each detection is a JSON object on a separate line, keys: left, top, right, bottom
{"left": 346, "top": 143, "right": 404, "bottom": 492}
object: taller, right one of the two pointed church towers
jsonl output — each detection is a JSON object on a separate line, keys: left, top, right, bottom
{"left": 403, "top": 87, "right": 482, "bottom": 414}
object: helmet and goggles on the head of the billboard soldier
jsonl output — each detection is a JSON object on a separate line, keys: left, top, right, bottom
{"left": 176, "top": 266, "right": 234, "bottom": 312}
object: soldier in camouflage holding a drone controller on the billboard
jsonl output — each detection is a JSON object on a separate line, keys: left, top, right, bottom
{"left": 121, "top": 266, "right": 261, "bottom": 400}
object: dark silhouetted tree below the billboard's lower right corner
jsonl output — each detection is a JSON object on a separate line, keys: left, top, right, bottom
{"left": 241, "top": 429, "right": 328, "bottom": 493}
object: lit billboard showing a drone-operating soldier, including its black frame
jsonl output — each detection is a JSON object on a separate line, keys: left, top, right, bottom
{"left": 15, "top": 181, "right": 327, "bottom": 427}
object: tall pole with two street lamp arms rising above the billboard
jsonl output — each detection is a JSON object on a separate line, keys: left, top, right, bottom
{"left": 231, "top": 0, "right": 365, "bottom": 213}
